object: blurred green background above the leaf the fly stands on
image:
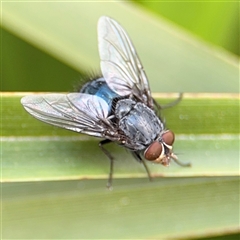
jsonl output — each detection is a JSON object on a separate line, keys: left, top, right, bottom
{"left": 1, "top": 1, "right": 239, "bottom": 92}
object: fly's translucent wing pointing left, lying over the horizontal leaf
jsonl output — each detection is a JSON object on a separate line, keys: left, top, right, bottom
{"left": 21, "top": 93, "right": 115, "bottom": 137}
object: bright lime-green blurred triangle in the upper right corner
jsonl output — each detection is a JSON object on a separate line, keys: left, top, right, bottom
{"left": 135, "top": 0, "right": 240, "bottom": 55}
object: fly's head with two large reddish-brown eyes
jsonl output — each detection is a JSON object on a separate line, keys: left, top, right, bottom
{"left": 144, "top": 130, "right": 177, "bottom": 166}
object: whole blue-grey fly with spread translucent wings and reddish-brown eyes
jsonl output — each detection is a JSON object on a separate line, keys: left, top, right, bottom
{"left": 21, "top": 16, "right": 190, "bottom": 188}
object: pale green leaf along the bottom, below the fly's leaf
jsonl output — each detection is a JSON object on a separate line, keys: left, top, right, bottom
{"left": 2, "top": 177, "right": 239, "bottom": 239}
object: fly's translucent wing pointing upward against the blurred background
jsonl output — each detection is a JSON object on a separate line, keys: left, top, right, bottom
{"left": 98, "top": 16, "right": 153, "bottom": 108}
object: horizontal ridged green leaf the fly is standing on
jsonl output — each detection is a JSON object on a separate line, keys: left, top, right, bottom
{"left": 2, "top": 94, "right": 239, "bottom": 181}
